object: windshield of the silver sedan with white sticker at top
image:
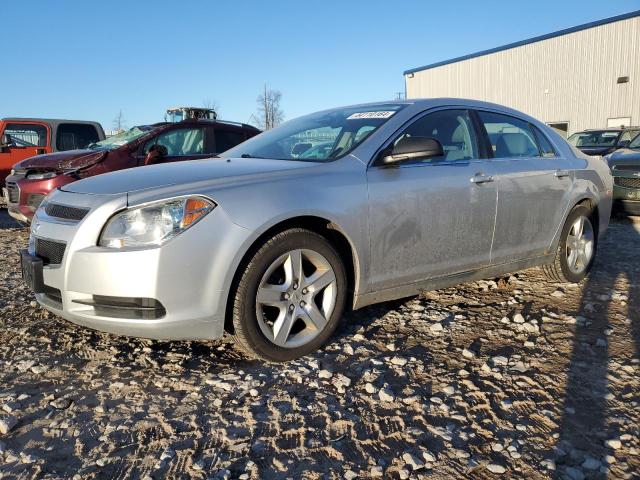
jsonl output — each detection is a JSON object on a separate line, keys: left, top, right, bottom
{"left": 222, "top": 104, "right": 405, "bottom": 162}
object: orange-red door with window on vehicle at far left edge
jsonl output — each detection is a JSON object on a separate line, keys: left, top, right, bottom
{"left": 0, "top": 121, "right": 51, "bottom": 184}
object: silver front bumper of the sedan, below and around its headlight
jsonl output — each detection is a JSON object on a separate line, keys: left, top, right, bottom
{"left": 32, "top": 191, "right": 250, "bottom": 340}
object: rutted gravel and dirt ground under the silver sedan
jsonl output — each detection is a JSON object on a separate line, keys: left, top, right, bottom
{"left": 0, "top": 212, "right": 640, "bottom": 479}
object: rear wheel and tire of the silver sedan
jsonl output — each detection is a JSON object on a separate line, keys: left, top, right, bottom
{"left": 542, "top": 205, "right": 598, "bottom": 283}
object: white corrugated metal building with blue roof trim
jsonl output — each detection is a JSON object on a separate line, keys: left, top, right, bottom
{"left": 404, "top": 10, "right": 640, "bottom": 134}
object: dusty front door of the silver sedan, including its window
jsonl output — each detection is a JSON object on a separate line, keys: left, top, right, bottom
{"left": 367, "top": 109, "right": 496, "bottom": 291}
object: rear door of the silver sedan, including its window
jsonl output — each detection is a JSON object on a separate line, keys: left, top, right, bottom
{"left": 477, "top": 111, "right": 575, "bottom": 264}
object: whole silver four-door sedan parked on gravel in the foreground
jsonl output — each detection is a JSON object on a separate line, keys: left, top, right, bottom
{"left": 21, "top": 99, "right": 612, "bottom": 361}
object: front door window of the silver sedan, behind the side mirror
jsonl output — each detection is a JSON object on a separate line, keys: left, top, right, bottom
{"left": 394, "top": 110, "right": 478, "bottom": 162}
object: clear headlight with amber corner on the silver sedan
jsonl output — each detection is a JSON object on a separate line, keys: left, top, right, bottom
{"left": 98, "top": 197, "right": 216, "bottom": 248}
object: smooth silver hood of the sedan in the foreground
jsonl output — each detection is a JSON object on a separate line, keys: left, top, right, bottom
{"left": 62, "top": 158, "right": 318, "bottom": 195}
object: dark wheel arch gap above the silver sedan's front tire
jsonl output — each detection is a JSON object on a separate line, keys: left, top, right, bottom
{"left": 224, "top": 215, "right": 361, "bottom": 333}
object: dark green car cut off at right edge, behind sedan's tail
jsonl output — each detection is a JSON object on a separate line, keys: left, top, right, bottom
{"left": 604, "top": 135, "right": 640, "bottom": 215}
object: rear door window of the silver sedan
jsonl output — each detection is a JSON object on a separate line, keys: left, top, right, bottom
{"left": 478, "top": 111, "right": 540, "bottom": 158}
